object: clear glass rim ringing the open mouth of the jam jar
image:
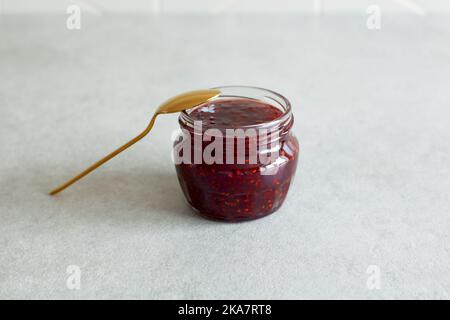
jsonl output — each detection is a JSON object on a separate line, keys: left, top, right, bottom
{"left": 179, "top": 85, "right": 292, "bottom": 129}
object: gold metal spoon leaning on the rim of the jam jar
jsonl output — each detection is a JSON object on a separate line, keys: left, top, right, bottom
{"left": 49, "top": 89, "right": 220, "bottom": 195}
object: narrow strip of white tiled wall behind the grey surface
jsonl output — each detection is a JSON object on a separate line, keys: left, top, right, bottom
{"left": 0, "top": 0, "right": 450, "bottom": 15}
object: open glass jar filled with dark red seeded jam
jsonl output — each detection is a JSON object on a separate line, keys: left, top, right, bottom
{"left": 174, "top": 86, "right": 299, "bottom": 221}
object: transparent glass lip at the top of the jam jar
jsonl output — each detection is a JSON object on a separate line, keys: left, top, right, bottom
{"left": 179, "top": 85, "right": 292, "bottom": 129}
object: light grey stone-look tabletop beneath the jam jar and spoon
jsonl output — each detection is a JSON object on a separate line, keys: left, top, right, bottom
{"left": 0, "top": 14, "right": 450, "bottom": 299}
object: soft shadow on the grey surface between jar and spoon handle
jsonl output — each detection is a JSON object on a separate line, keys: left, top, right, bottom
{"left": 39, "top": 168, "right": 202, "bottom": 224}
